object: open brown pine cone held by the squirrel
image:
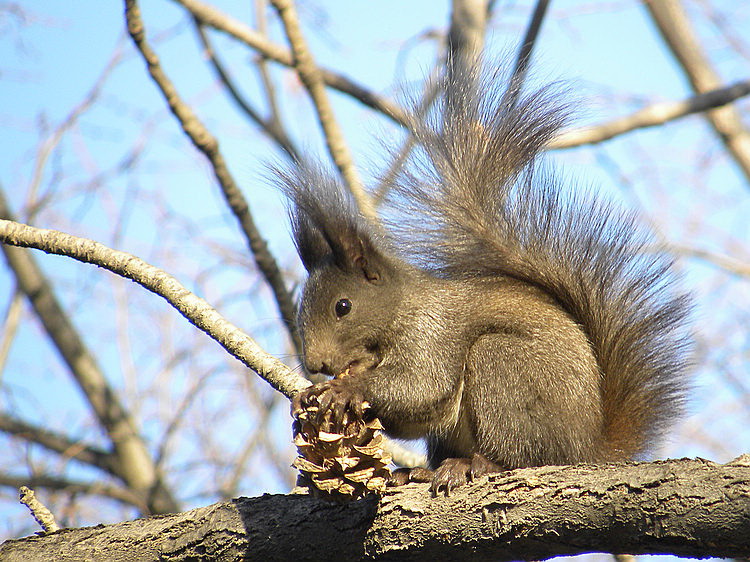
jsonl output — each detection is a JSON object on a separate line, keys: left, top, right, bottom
{"left": 292, "top": 382, "right": 391, "bottom": 501}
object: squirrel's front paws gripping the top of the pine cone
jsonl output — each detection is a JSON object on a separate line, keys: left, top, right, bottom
{"left": 292, "top": 379, "right": 366, "bottom": 430}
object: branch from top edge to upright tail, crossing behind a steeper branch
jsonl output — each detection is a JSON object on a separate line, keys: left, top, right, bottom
{"left": 173, "top": 0, "right": 407, "bottom": 125}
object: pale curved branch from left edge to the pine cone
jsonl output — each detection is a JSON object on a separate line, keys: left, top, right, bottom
{"left": 0, "top": 214, "right": 310, "bottom": 397}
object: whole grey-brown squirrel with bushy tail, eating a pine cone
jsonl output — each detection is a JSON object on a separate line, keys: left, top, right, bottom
{"left": 281, "top": 62, "right": 689, "bottom": 492}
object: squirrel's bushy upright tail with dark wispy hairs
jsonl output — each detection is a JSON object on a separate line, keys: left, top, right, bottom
{"left": 391, "top": 63, "right": 688, "bottom": 459}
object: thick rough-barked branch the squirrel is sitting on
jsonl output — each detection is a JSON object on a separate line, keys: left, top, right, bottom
{"left": 0, "top": 455, "right": 750, "bottom": 562}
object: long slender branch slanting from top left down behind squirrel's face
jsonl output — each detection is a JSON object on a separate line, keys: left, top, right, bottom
{"left": 125, "top": 0, "right": 302, "bottom": 350}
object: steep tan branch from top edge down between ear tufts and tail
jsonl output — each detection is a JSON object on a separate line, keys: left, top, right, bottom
{"left": 271, "top": 0, "right": 375, "bottom": 218}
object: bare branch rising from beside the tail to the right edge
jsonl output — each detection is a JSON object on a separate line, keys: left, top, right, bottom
{"left": 549, "top": 80, "right": 750, "bottom": 149}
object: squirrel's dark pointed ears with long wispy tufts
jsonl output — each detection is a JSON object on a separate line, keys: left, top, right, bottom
{"left": 274, "top": 163, "right": 389, "bottom": 283}
